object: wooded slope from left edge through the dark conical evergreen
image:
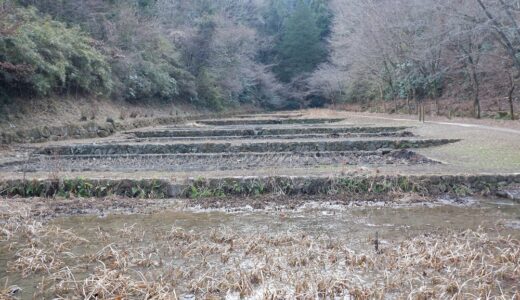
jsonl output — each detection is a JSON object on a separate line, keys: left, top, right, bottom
{"left": 0, "top": 0, "right": 331, "bottom": 111}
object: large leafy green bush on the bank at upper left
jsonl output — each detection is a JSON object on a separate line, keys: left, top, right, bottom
{"left": 0, "top": 8, "right": 112, "bottom": 96}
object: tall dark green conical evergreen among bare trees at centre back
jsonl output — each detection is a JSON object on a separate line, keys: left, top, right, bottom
{"left": 274, "top": 1, "right": 326, "bottom": 82}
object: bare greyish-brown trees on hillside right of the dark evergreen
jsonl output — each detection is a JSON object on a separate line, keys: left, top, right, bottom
{"left": 310, "top": 0, "right": 520, "bottom": 118}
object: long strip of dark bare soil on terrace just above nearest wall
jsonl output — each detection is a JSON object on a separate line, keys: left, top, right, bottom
{"left": 0, "top": 149, "right": 439, "bottom": 173}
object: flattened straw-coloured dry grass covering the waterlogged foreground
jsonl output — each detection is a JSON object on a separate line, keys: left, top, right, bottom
{"left": 0, "top": 206, "right": 520, "bottom": 299}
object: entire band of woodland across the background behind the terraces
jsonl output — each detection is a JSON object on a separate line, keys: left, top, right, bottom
{"left": 0, "top": 0, "right": 520, "bottom": 118}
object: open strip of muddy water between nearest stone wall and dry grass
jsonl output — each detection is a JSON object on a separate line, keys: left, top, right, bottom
{"left": 49, "top": 198, "right": 520, "bottom": 245}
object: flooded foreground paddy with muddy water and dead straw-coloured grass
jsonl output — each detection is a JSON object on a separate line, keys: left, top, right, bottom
{"left": 0, "top": 198, "right": 520, "bottom": 299}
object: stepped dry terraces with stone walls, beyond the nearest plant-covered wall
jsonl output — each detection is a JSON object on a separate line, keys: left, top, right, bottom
{"left": 0, "top": 118, "right": 456, "bottom": 172}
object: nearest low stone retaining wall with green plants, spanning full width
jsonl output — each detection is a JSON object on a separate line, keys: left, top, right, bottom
{"left": 0, "top": 174, "right": 520, "bottom": 201}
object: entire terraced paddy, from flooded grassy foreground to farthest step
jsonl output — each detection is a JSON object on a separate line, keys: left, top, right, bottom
{"left": 0, "top": 112, "right": 520, "bottom": 300}
